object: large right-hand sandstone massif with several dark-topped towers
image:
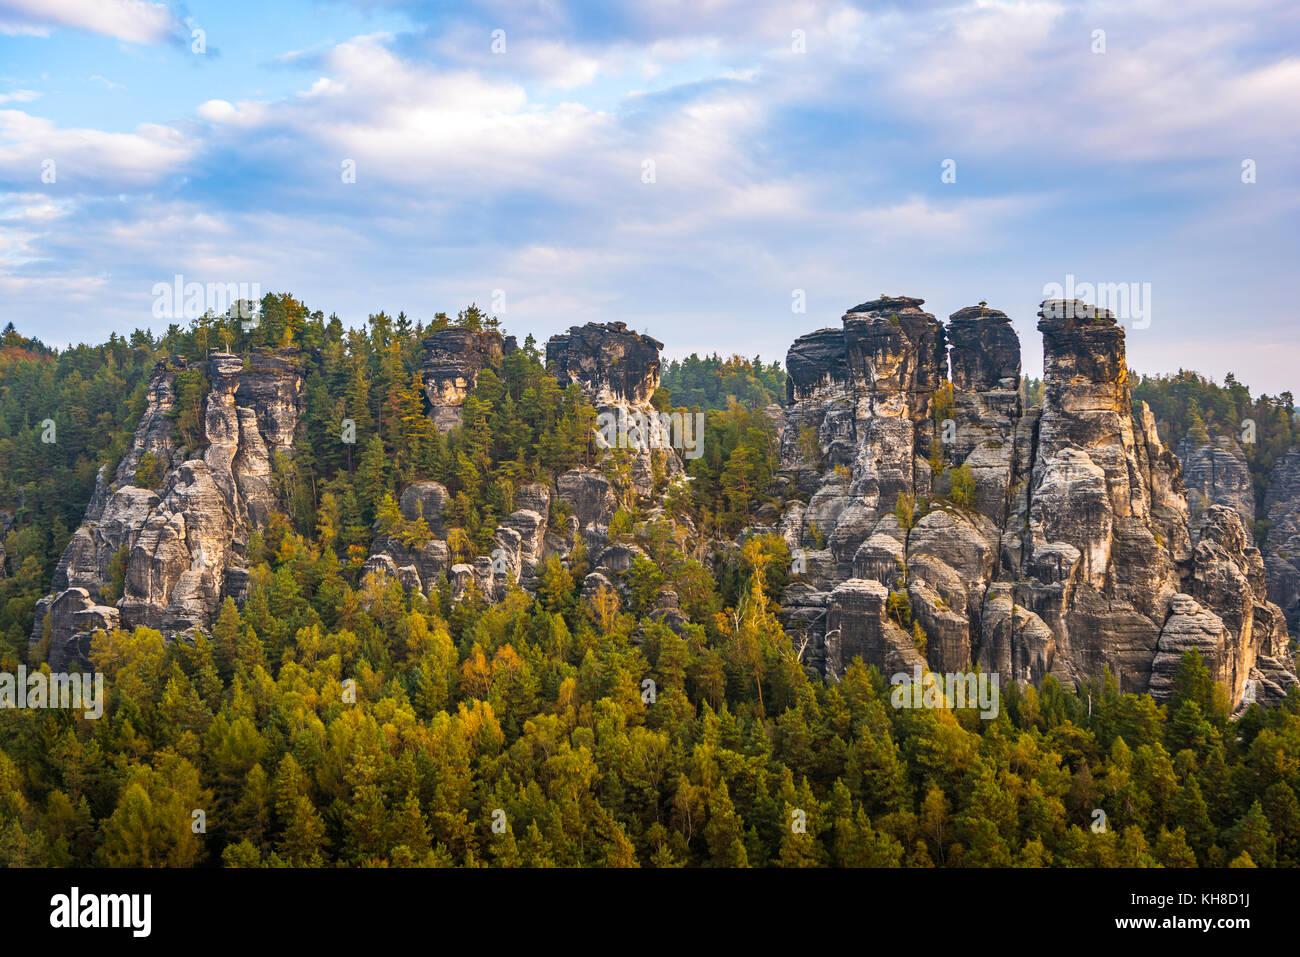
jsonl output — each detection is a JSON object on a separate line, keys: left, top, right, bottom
{"left": 780, "top": 298, "right": 1300, "bottom": 705}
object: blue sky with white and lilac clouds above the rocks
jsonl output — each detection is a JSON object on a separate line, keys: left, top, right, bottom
{"left": 0, "top": 0, "right": 1300, "bottom": 394}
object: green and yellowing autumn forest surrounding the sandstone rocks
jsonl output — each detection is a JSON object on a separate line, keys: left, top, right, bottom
{"left": 0, "top": 300, "right": 1300, "bottom": 867}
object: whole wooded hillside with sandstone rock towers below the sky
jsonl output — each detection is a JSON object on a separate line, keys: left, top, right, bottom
{"left": 0, "top": 295, "right": 1300, "bottom": 866}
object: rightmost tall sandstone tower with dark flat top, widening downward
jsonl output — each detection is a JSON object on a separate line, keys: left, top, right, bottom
{"left": 1018, "top": 300, "right": 1187, "bottom": 692}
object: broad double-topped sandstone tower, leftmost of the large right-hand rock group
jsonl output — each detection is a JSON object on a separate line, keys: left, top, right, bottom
{"left": 780, "top": 298, "right": 948, "bottom": 674}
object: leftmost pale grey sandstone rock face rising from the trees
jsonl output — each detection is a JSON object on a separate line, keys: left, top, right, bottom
{"left": 33, "top": 352, "right": 303, "bottom": 671}
